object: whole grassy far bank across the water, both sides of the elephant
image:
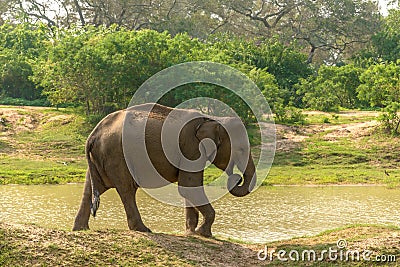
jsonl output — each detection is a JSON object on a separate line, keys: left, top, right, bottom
{"left": 0, "top": 106, "right": 400, "bottom": 187}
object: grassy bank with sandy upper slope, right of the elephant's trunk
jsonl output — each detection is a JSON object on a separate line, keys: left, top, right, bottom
{"left": 265, "top": 111, "right": 400, "bottom": 187}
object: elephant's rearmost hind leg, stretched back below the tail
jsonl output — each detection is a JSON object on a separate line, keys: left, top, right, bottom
{"left": 72, "top": 171, "right": 92, "bottom": 231}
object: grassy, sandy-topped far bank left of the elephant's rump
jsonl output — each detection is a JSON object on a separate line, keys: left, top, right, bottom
{"left": 0, "top": 106, "right": 91, "bottom": 184}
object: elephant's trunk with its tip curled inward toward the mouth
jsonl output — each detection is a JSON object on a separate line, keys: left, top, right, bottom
{"left": 228, "top": 155, "right": 257, "bottom": 197}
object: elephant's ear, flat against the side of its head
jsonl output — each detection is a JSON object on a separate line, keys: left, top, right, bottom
{"left": 196, "top": 120, "right": 222, "bottom": 159}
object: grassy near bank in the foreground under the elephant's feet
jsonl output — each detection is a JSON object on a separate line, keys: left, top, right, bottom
{"left": 0, "top": 223, "right": 400, "bottom": 266}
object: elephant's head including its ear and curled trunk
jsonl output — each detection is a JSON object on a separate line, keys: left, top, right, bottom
{"left": 196, "top": 117, "right": 257, "bottom": 197}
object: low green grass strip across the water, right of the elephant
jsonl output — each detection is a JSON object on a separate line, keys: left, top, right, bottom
{"left": 266, "top": 135, "right": 400, "bottom": 185}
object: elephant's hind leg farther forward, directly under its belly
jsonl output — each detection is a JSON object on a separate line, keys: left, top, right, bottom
{"left": 117, "top": 185, "right": 151, "bottom": 232}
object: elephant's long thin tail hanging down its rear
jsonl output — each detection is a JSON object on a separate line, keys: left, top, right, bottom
{"left": 86, "top": 136, "right": 103, "bottom": 217}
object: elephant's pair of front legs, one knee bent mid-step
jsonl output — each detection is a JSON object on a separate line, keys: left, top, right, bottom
{"left": 178, "top": 171, "right": 215, "bottom": 237}
